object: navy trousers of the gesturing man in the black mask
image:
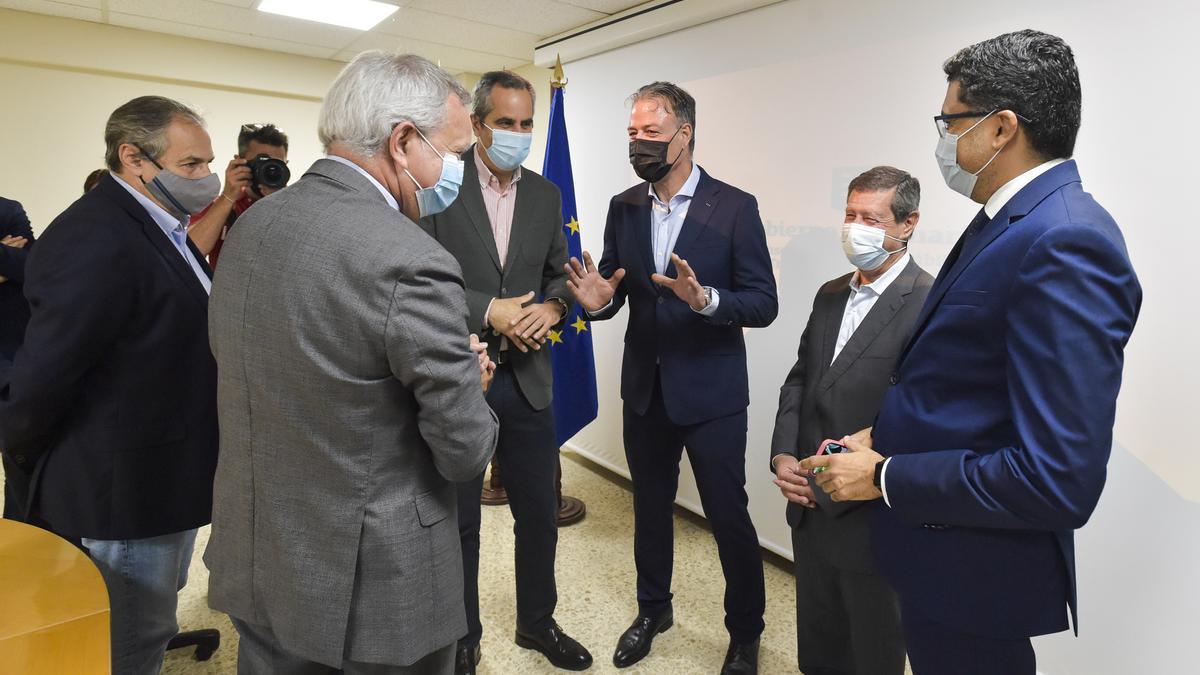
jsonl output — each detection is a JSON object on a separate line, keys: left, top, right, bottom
{"left": 624, "top": 374, "right": 767, "bottom": 643}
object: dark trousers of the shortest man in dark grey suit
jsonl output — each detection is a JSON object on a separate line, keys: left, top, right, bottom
{"left": 792, "top": 523, "right": 905, "bottom": 675}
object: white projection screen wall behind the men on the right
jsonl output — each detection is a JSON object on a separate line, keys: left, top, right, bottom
{"left": 565, "top": 0, "right": 1200, "bottom": 675}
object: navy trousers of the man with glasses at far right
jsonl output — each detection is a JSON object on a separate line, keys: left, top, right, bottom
{"left": 901, "top": 603, "right": 1037, "bottom": 675}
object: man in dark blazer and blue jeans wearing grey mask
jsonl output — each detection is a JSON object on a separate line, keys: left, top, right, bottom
{"left": 0, "top": 96, "right": 220, "bottom": 674}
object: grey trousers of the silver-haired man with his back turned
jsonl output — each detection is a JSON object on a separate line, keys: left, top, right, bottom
{"left": 229, "top": 616, "right": 455, "bottom": 675}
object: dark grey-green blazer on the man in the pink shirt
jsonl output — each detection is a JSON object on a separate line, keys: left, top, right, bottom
{"left": 420, "top": 145, "right": 575, "bottom": 410}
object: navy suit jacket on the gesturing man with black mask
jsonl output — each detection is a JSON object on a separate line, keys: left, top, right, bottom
{"left": 592, "top": 169, "right": 779, "bottom": 424}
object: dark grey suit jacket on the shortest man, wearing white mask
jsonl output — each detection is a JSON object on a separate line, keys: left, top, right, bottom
{"left": 770, "top": 254, "right": 934, "bottom": 573}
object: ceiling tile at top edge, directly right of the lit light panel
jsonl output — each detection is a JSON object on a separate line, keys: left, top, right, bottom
{"left": 409, "top": 0, "right": 605, "bottom": 37}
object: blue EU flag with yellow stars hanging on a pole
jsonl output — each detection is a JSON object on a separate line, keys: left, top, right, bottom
{"left": 541, "top": 84, "right": 599, "bottom": 447}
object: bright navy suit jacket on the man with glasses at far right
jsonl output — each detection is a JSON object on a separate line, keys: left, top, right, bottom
{"left": 872, "top": 161, "right": 1141, "bottom": 638}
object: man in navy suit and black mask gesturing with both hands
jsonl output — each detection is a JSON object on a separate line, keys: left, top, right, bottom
{"left": 566, "top": 82, "right": 779, "bottom": 673}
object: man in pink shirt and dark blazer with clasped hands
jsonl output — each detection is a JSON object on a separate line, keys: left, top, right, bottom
{"left": 421, "top": 71, "right": 592, "bottom": 674}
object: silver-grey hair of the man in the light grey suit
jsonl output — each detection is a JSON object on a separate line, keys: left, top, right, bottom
{"left": 317, "top": 50, "right": 469, "bottom": 157}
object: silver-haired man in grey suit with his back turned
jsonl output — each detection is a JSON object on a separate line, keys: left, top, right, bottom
{"left": 204, "top": 52, "right": 497, "bottom": 674}
